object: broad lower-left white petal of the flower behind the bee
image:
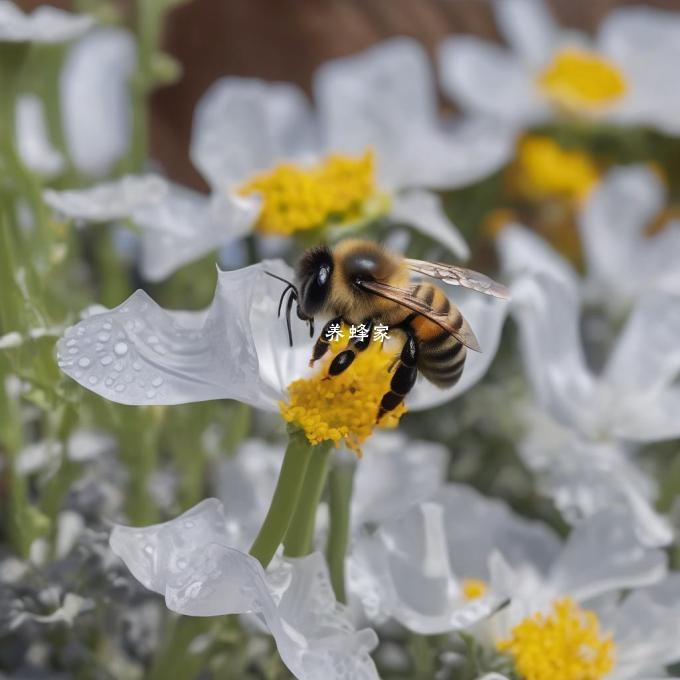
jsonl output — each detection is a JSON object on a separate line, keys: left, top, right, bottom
{"left": 133, "top": 184, "right": 260, "bottom": 281}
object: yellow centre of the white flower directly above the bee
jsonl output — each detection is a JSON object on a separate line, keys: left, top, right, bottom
{"left": 239, "top": 150, "right": 386, "bottom": 236}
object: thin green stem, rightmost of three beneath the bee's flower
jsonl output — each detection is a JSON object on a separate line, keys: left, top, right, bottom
{"left": 326, "top": 463, "right": 355, "bottom": 602}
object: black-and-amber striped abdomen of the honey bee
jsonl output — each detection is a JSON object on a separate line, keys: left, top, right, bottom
{"left": 411, "top": 283, "right": 467, "bottom": 387}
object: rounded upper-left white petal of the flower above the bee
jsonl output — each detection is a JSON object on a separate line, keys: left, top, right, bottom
{"left": 191, "top": 78, "right": 316, "bottom": 192}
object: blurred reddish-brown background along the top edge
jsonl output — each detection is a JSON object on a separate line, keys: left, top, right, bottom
{"left": 18, "top": 0, "right": 680, "bottom": 188}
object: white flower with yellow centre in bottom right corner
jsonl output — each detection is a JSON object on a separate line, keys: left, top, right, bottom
{"left": 475, "top": 510, "right": 680, "bottom": 680}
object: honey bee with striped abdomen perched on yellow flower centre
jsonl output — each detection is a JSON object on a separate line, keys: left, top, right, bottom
{"left": 271, "top": 239, "right": 509, "bottom": 420}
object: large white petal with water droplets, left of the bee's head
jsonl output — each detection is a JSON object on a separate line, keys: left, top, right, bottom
{"left": 57, "top": 262, "right": 291, "bottom": 410}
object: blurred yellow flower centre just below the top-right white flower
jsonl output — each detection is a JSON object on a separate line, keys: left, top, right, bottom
{"left": 513, "top": 135, "right": 599, "bottom": 202}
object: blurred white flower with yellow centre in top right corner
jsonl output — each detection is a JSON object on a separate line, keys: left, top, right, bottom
{"left": 440, "top": 0, "right": 680, "bottom": 135}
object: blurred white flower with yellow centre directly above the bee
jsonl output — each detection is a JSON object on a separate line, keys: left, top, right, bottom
{"left": 48, "top": 39, "right": 513, "bottom": 280}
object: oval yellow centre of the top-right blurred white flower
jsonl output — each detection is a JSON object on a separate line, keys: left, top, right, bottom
{"left": 538, "top": 48, "right": 627, "bottom": 112}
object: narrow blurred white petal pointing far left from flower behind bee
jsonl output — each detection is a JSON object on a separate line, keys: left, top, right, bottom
{"left": 43, "top": 175, "right": 168, "bottom": 222}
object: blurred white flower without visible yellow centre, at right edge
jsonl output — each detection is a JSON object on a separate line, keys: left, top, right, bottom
{"left": 500, "top": 242, "right": 680, "bottom": 544}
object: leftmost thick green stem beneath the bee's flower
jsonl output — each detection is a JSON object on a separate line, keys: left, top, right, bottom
{"left": 250, "top": 426, "right": 314, "bottom": 569}
